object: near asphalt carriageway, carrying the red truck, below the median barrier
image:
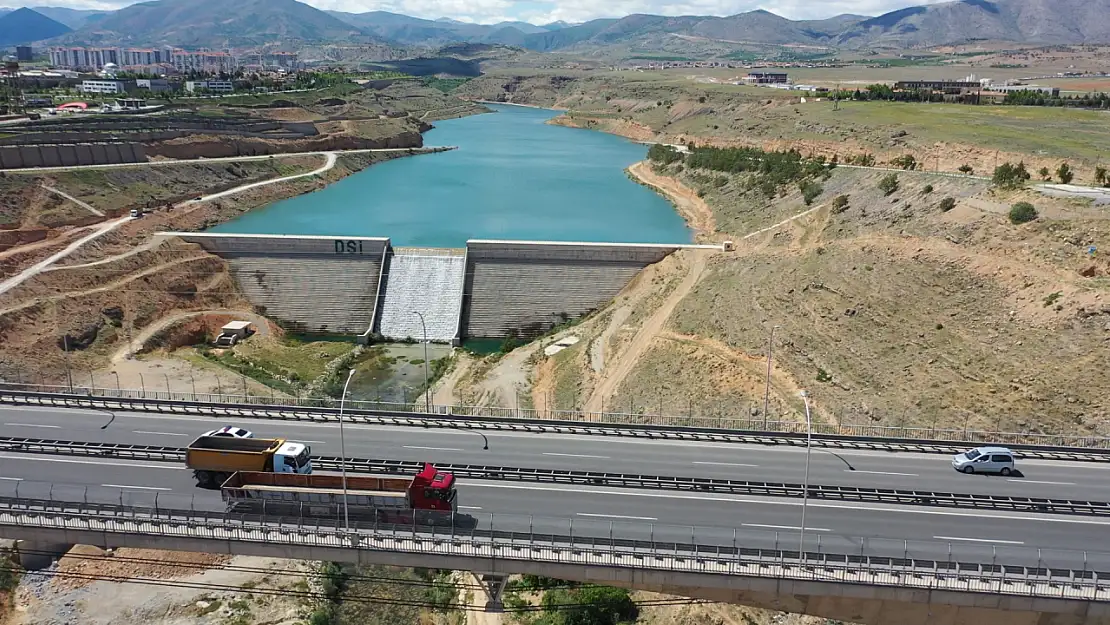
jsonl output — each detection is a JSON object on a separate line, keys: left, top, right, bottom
{"left": 0, "top": 454, "right": 1110, "bottom": 571}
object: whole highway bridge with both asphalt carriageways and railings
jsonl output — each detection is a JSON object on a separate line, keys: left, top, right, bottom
{"left": 0, "top": 392, "right": 1110, "bottom": 625}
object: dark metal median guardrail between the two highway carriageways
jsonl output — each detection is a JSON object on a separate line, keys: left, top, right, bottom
{"left": 0, "top": 436, "right": 1110, "bottom": 516}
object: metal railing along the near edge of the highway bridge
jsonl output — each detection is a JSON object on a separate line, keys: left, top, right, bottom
{"left": 0, "top": 497, "right": 1110, "bottom": 602}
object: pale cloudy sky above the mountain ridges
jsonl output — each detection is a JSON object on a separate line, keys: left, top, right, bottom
{"left": 10, "top": 0, "right": 942, "bottom": 24}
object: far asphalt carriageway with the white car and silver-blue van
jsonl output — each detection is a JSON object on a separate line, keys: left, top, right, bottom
{"left": 0, "top": 407, "right": 1110, "bottom": 501}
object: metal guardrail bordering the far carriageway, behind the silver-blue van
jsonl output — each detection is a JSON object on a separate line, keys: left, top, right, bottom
{"left": 0, "top": 389, "right": 1110, "bottom": 463}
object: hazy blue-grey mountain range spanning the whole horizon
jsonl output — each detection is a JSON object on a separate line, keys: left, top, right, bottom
{"left": 0, "top": 0, "right": 1110, "bottom": 52}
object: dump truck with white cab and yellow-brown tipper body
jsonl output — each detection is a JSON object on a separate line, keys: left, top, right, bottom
{"left": 185, "top": 436, "right": 312, "bottom": 488}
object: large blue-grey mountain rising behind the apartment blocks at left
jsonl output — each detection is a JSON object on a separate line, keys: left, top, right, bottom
{"left": 63, "top": 0, "right": 374, "bottom": 48}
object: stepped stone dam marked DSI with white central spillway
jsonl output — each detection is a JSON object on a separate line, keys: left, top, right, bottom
{"left": 159, "top": 232, "right": 722, "bottom": 345}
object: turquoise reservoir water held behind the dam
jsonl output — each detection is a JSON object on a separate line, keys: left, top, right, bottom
{"left": 212, "top": 107, "right": 693, "bottom": 248}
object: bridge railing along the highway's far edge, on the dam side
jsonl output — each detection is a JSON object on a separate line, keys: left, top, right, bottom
{"left": 0, "top": 383, "right": 1110, "bottom": 460}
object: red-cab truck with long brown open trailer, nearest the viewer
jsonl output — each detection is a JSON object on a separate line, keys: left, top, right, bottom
{"left": 220, "top": 463, "right": 458, "bottom": 525}
